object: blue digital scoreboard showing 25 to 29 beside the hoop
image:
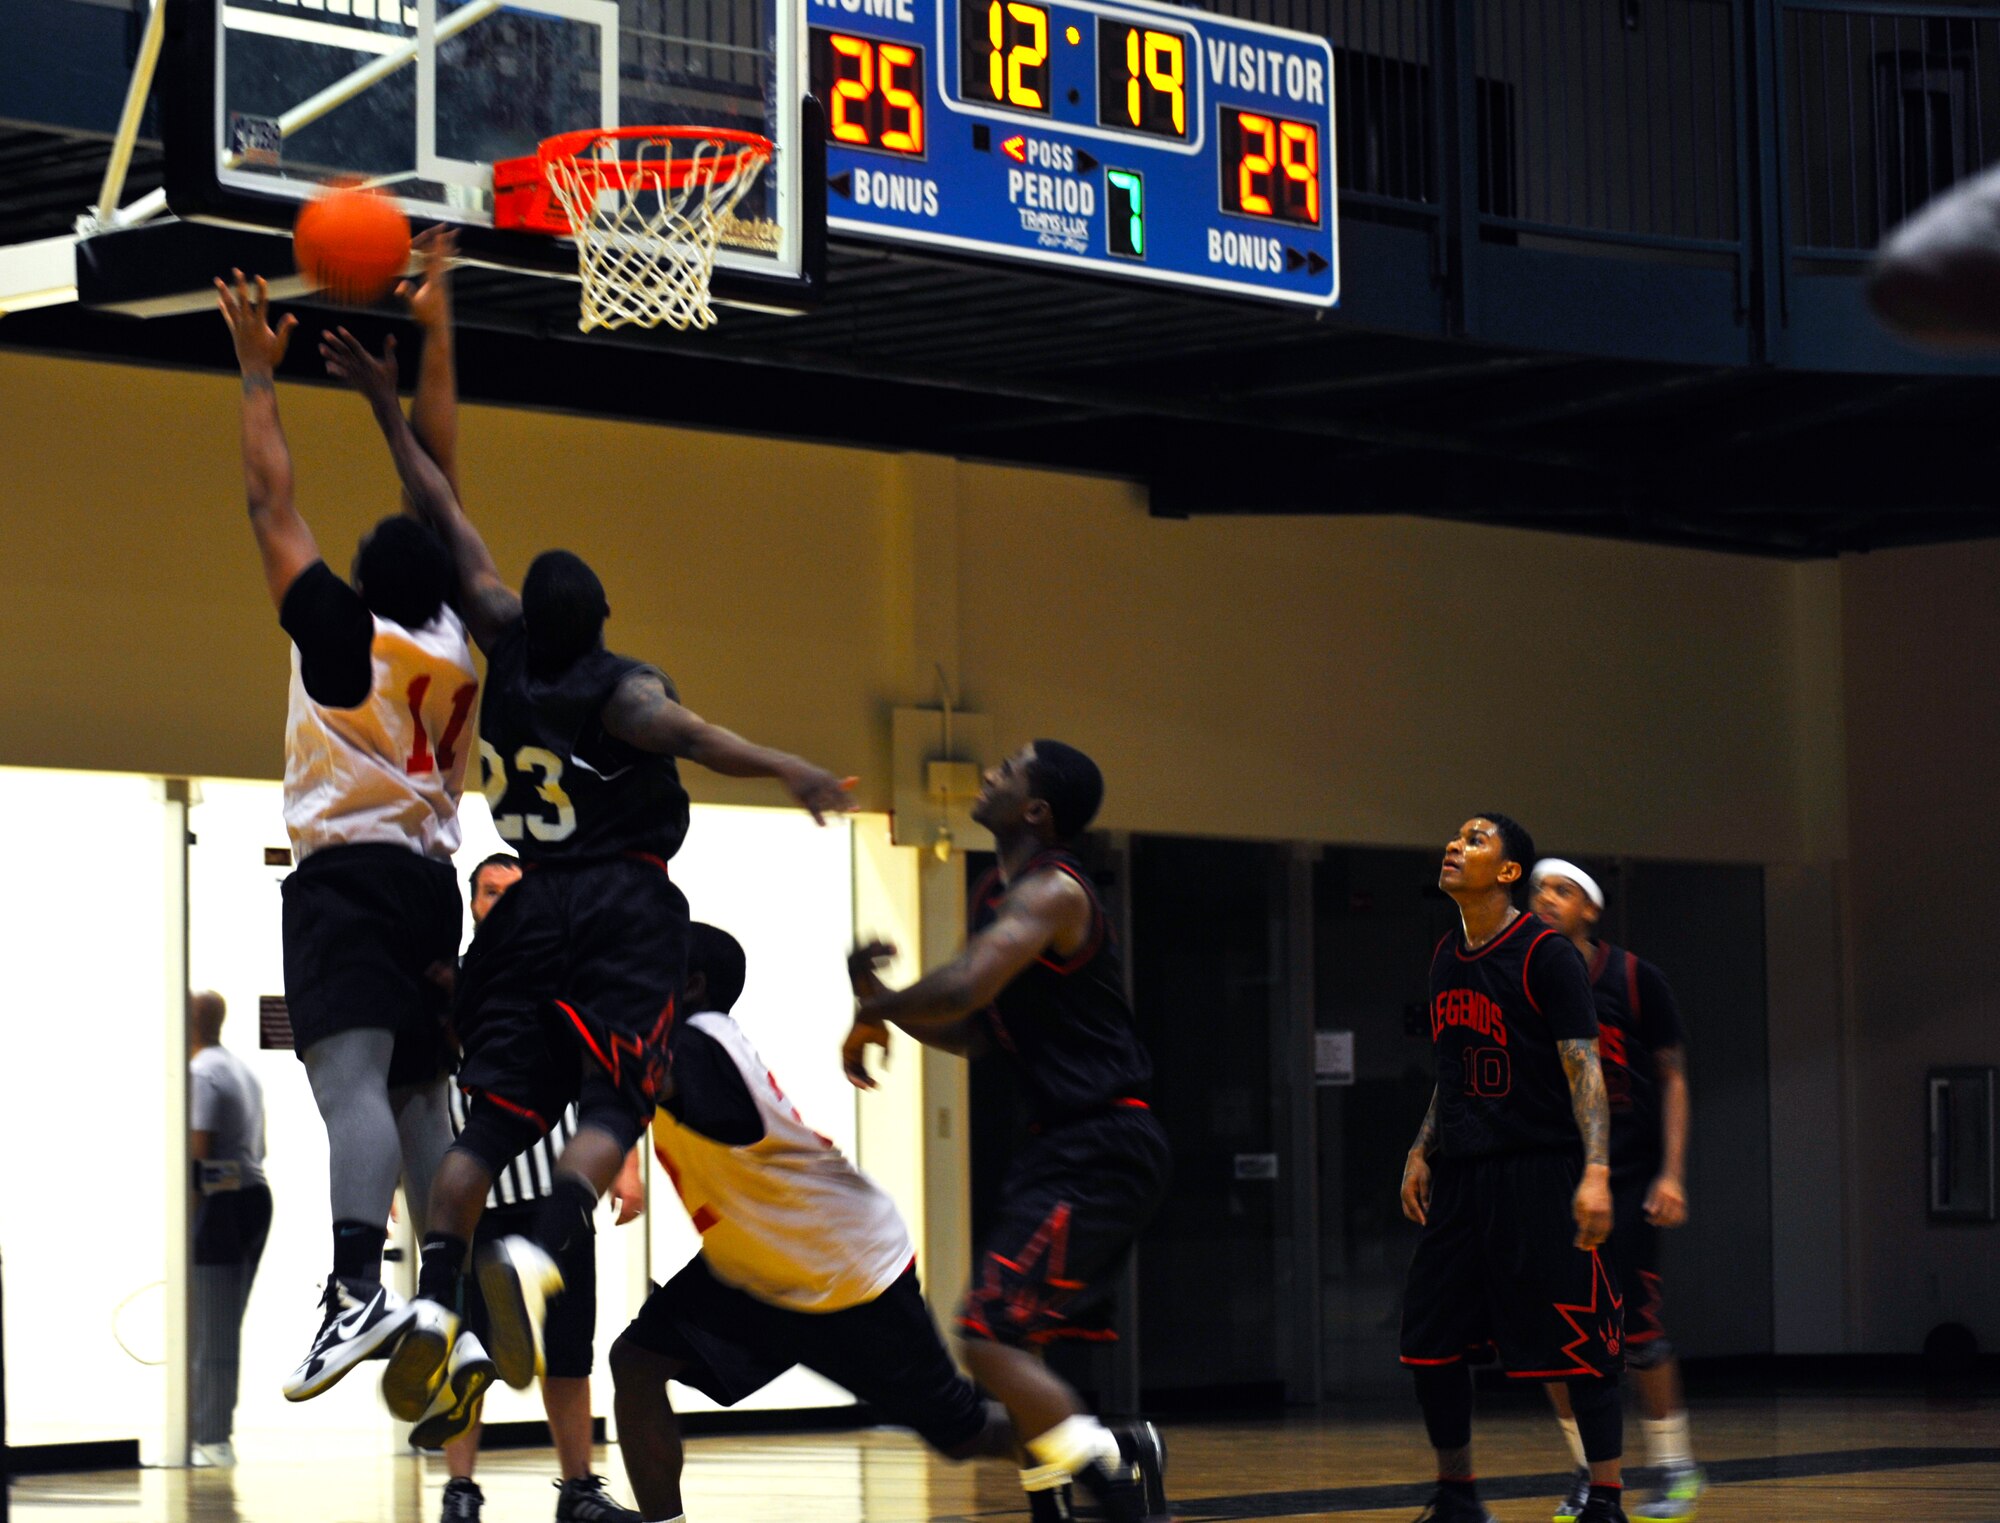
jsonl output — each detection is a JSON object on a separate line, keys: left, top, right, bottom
{"left": 808, "top": 0, "right": 1340, "bottom": 308}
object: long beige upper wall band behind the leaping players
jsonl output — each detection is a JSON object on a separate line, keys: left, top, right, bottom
{"left": 0, "top": 354, "right": 1838, "bottom": 861}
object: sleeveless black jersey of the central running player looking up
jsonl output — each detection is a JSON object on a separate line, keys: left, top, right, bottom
{"left": 972, "top": 851, "right": 1152, "bottom": 1125}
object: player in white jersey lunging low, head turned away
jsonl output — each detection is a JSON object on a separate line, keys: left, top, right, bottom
{"left": 612, "top": 923, "right": 1014, "bottom": 1521}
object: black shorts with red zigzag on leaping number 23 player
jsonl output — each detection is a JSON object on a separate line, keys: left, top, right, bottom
{"left": 454, "top": 857, "right": 688, "bottom": 1147}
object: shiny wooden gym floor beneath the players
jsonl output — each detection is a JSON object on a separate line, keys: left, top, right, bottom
{"left": 12, "top": 1395, "right": 2000, "bottom": 1523}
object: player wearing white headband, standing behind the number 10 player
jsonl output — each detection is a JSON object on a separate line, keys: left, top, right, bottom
{"left": 1532, "top": 857, "right": 1706, "bottom": 1523}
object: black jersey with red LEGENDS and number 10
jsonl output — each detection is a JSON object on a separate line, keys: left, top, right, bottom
{"left": 1430, "top": 915, "right": 1598, "bottom": 1157}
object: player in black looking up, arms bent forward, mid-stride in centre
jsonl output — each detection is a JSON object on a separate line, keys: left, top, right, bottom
{"left": 844, "top": 740, "right": 1168, "bottom": 1523}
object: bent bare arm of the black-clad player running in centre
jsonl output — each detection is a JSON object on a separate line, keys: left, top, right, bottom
{"left": 846, "top": 873, "right": 1094, "bottom": 1089}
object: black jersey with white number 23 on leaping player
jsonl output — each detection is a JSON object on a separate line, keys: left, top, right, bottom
{"left": 480, "top": 620, "right": 688, "bottom": 863}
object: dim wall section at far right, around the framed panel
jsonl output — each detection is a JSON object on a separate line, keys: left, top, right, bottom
{"left": 1820, "top": 542, "right": 2000, "bottom": 1353}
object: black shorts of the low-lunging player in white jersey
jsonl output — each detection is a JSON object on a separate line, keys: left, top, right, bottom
{"left": 624, "top": 1253, "right": 986, "bottom": 1453}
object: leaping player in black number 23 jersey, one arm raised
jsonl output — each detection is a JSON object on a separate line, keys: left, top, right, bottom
{"left": 320, "top": 328, "right": 852, "bottom": 1421}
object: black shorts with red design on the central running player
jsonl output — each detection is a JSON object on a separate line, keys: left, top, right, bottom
{"left": 958, "top": 1101, "right": 1172, "bottom": 1347}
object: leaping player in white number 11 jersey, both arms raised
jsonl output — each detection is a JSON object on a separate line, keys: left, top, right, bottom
{"left": 216, "top": 246, "right": 478, "bottom": 1401}
